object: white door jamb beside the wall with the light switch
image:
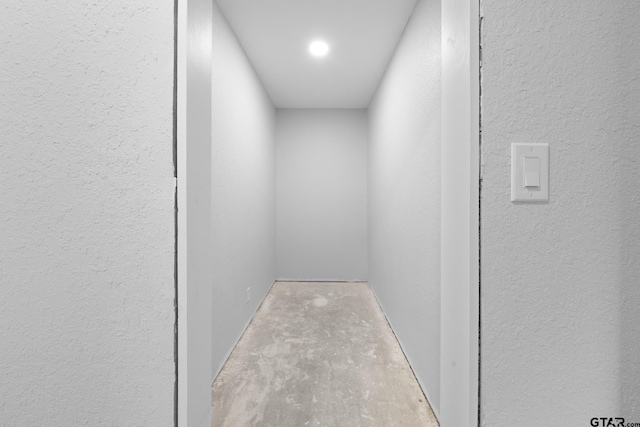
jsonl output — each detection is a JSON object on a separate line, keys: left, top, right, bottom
{"left": 440, "top": 0, "right": 480, "bottom": 427}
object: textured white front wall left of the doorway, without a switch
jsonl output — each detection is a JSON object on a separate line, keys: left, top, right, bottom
{"left": 0, "top": 0, "right": 175, "bottom": 426}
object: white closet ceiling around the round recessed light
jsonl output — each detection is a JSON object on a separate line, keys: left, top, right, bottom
{"left": 218, "top": 0, "right": 416, "bottom": 108}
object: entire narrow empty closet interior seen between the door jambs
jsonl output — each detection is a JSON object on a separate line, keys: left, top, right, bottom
{"left": 208, "top": 0, "right": 441, "bottom": 427}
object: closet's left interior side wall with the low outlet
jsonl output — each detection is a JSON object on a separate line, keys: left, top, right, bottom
{"left": 211, "top": 2, "right": 276, "bottom": 379}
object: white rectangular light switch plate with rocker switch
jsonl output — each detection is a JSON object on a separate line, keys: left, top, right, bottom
{"left": 511, "top": 143, "right": 549, "bottom": 202}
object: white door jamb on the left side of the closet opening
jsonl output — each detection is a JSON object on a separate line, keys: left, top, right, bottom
{"left": 175, "top": 0, "right": 213, "bottom": 427}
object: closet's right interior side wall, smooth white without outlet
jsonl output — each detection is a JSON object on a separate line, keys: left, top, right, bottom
{"left": 369, "top": 0, "right": 441, "bottom": 412}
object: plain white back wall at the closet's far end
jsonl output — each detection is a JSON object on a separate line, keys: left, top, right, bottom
{"left": 276, "top": 110, "right": 367, "bottom": 280}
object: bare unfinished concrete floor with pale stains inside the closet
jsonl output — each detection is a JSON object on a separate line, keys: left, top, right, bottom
{"left": 212, "top": 282, "right": 438, "bottom": 427}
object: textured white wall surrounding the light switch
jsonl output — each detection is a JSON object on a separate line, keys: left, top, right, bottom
{"left": 481, "top": 0, "right": 640, "bottom": 427}
